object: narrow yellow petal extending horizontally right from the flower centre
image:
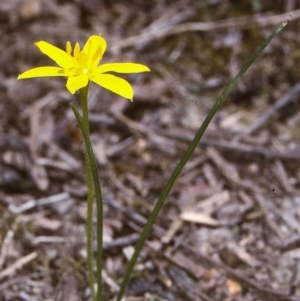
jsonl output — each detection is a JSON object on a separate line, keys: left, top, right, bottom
{"left": 94, "top": 63, "right": 150, "bottom": 74}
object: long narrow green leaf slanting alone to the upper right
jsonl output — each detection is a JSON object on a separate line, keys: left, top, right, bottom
{"left": 116, "top": 22, "right": 288, "bottom": 301}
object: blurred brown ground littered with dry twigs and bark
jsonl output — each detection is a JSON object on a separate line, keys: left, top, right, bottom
{"left": 0, "top": 0, "right": 300, "bottom": 301}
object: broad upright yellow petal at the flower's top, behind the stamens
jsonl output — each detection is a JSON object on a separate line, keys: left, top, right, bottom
{"left": 82, "top": 35, "right": 106, "bottom": 70}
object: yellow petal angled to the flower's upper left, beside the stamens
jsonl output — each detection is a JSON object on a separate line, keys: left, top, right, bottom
{"left": 35, "top": 41, "right": 74, "bottom": 69}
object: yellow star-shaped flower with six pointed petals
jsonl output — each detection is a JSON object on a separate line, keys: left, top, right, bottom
{"left": 18, "top": 35, "right": 150, "bottom": 100}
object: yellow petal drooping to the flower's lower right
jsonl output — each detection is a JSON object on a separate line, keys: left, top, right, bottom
{"left": 91, "top": 74, "right": 133, "bottom": 101}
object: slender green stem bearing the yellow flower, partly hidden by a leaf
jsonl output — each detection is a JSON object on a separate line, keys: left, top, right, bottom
{"left": 80, "top": 86, "right": 97, "bottom": 301}
